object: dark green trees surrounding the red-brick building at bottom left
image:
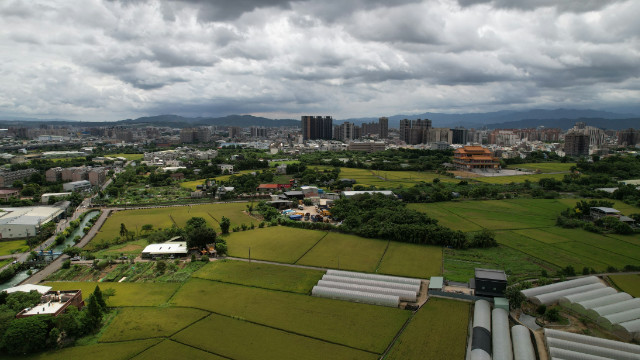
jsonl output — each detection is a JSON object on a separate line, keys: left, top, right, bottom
{"left": 0, "top": 286, "right": 108, "bottom": 355}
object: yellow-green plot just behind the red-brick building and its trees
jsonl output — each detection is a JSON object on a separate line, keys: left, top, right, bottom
{"left": 45, "top": 281, "right": 180, "bottom": 307}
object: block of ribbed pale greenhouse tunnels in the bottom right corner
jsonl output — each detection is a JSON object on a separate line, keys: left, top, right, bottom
{"left": 544, "top": 329, "right": 640, "bottom": 360}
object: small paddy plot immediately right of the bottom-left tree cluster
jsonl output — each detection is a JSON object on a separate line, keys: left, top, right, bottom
{"left": 100, "top": 307, "right": 209, "bottom": 342}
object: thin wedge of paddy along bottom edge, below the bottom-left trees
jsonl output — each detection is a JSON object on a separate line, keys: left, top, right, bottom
{"left": 2, "top": 339, "right": 160, "bottom": 360}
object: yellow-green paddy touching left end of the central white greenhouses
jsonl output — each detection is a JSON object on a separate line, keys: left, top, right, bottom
{"left": 193, "top": 260, "right": 324, "bottom": 294}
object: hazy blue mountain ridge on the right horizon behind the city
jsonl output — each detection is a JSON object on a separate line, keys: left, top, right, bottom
{"left": 486, "top": 117, "right": 640, "bottom": 130}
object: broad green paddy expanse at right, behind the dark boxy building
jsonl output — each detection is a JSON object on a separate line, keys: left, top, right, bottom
{"left": 409, "top": 199, "right": 640, "bottom": 281}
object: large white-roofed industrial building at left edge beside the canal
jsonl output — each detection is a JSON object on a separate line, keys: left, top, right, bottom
{"left": 0, "top": 206, "right": 64, "bottom": 239}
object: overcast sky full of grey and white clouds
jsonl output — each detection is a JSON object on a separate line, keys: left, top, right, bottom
{"left": 0, "top": 0, "right": 640, "bottom": 121}
